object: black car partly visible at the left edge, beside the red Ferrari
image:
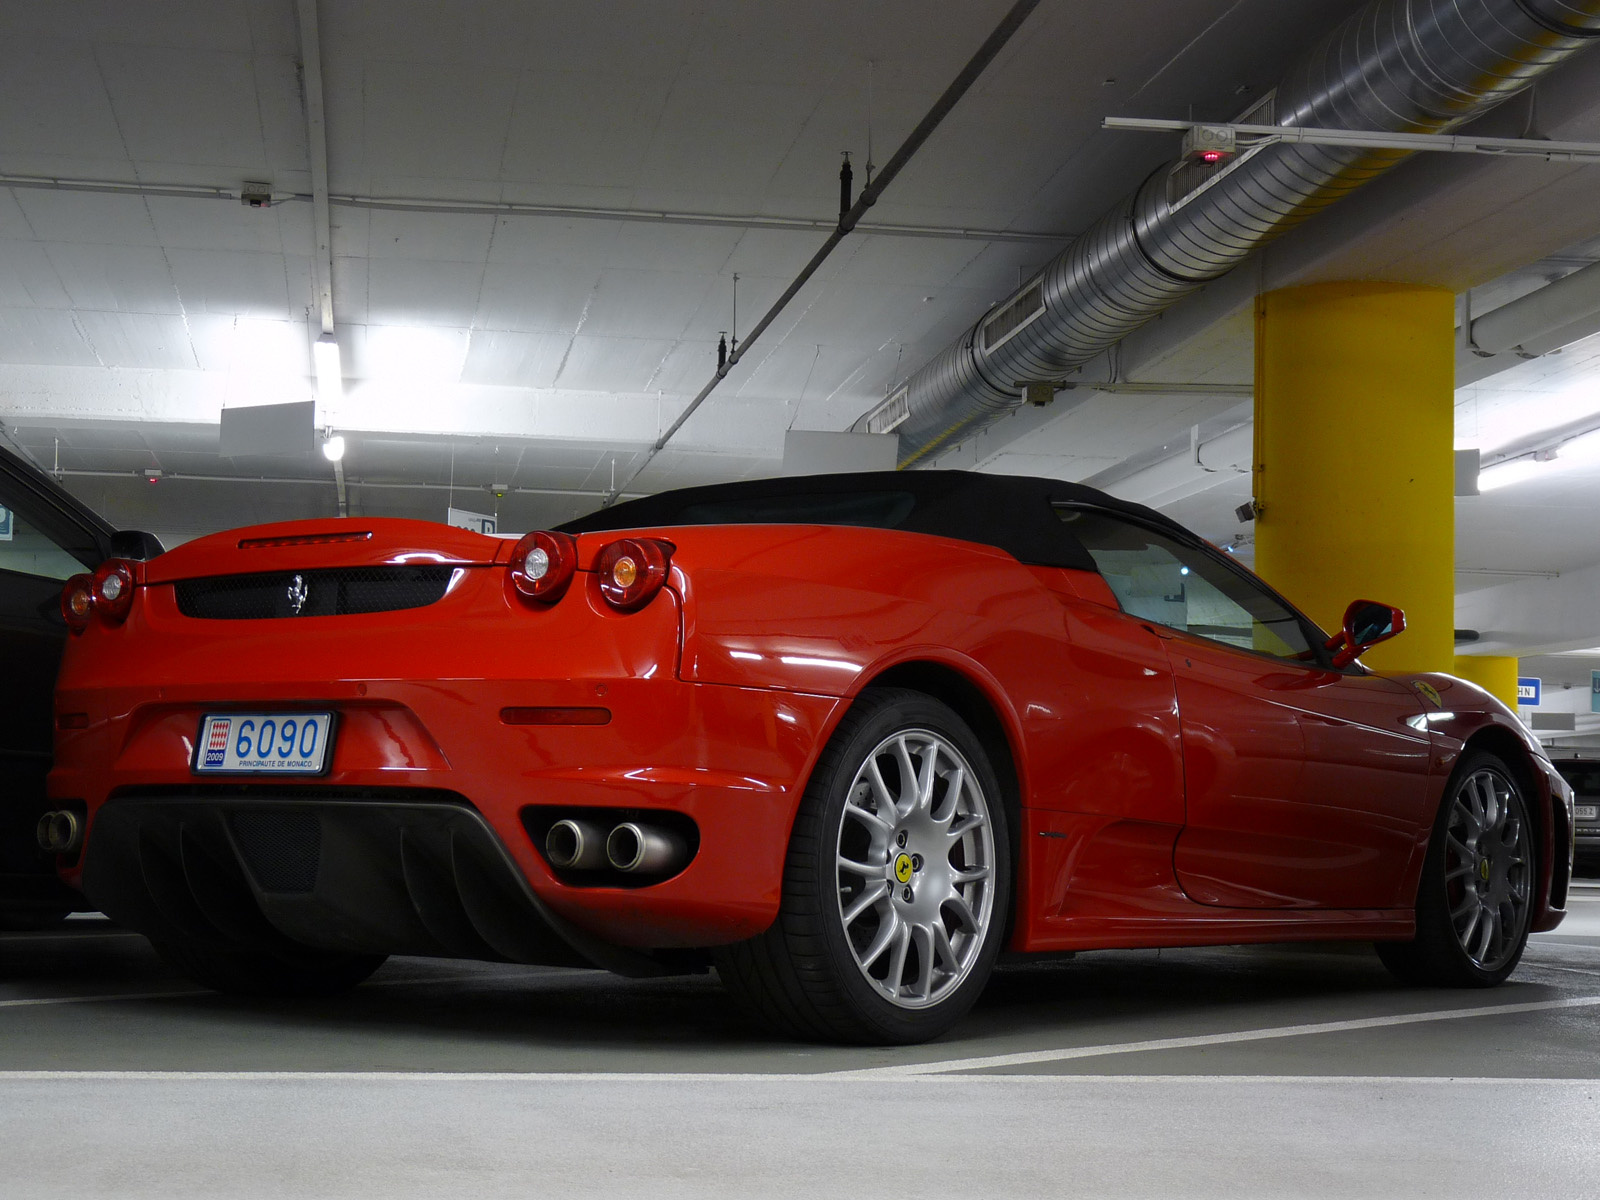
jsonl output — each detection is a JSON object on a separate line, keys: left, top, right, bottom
{"left": 0, "top": 448, "right": 162, "bottom": 930}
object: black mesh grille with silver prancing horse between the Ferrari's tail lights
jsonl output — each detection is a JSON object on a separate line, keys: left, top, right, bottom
{"left": 173, "top": 565, "right": 462, "bottom": 621}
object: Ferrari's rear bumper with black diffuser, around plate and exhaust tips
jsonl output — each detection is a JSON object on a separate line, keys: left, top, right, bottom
{"left": 51, "top": 678, "right": 838, "bottom": 962}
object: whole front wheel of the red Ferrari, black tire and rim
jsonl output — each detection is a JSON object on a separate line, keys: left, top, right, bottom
{"left": 1378, "top": 750, "right": 1539, "bottom": 987}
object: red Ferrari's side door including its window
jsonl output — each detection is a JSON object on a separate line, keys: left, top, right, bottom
{"left": 1070, "top": 510, "right": 1430, "bottom": 907}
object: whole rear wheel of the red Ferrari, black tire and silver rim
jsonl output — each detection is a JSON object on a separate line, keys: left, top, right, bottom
{"left": 715, "top": 688, "right": 1011, "bottom": 1045}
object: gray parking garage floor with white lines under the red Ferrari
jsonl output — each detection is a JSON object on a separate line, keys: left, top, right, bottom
{"left": 0, "top": 883, "right": 1600, "bottom": 1197}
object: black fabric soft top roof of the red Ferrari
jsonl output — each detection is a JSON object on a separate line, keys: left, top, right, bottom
{"left": 560, "top": 470, "right": 1195, "bottom": 571}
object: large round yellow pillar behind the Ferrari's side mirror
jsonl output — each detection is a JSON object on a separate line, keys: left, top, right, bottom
{"left": 1254, "top": 283, "right": 1456, "bottom": 670}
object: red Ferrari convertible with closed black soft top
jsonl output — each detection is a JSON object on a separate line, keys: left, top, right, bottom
{"left": 50, "top": 472, "right": 1573, "bottom": 1042}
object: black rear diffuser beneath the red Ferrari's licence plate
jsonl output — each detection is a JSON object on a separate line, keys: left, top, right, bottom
{"left": 83, "top": 795, "right": 668, "bottom": 974}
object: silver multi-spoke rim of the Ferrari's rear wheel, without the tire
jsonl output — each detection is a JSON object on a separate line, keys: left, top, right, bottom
{"left": 835, "top": 728, "right": 995, "bottom": 1008}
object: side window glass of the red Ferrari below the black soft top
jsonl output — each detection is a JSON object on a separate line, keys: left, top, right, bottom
{"left": 1058, "top": 509, "right": 1317, "bottom": 662}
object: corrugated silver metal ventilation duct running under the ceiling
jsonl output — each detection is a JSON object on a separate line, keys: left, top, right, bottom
{"left": 883, "top": 0, "right": 1600, "bottom": 467}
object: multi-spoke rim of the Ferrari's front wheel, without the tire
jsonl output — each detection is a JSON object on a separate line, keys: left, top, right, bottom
{"left": 1445, "top": 768, "right": 1533, "bottom": 971}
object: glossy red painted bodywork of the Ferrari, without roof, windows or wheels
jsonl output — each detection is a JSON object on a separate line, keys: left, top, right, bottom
{"left": 51, "top": 520, "right": 1570, "bottom": 950}
